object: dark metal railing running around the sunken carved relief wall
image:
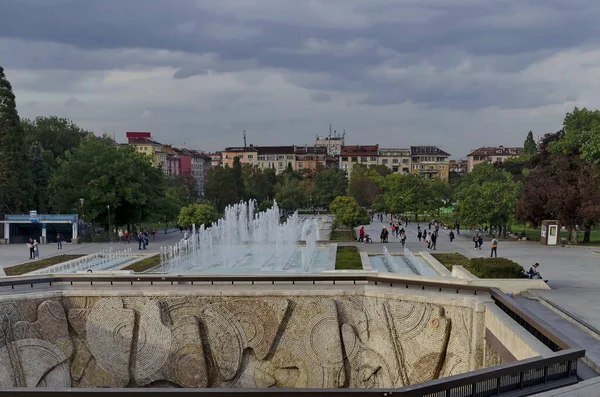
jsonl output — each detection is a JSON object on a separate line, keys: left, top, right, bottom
{"left": 0, "top": 273, "right": 585, "bottom": 397}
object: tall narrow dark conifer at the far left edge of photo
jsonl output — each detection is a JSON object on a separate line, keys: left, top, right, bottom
{"left": 0, "top": 67, "right": 31, "bottom": 213}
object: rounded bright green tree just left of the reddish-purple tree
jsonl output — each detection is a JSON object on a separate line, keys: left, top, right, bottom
{"left": 455, "top": 163, "right": 518, "bottom": 233}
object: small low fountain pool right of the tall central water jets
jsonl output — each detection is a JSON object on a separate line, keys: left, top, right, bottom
{"left": 369, "top": 247, "right": 440, "bottom": 277}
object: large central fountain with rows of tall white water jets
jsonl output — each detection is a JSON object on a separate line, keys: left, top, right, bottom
{"left": 154, "top": 201, "right": 328, "bottom": 273}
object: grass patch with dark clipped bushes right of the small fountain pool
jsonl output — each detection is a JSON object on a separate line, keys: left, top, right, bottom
{"left": 431, "top": 253, "right": 523, "bottom": 278}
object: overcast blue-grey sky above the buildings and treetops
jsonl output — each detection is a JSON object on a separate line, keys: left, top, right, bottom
{"left": 0, "top": 0, "right": 600, "bottom": 158}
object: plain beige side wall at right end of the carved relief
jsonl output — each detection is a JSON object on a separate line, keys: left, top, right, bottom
{"left": 485, "top": 303, "right": 553, "bottom": 360}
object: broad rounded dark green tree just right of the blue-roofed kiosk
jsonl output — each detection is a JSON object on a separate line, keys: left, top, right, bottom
{"left": 49, "top": 137, "right": 164, "bottom": 229}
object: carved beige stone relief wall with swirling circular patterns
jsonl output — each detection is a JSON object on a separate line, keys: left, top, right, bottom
{"left": 0, "top": 296, "right": 483, "bottom": 388}
